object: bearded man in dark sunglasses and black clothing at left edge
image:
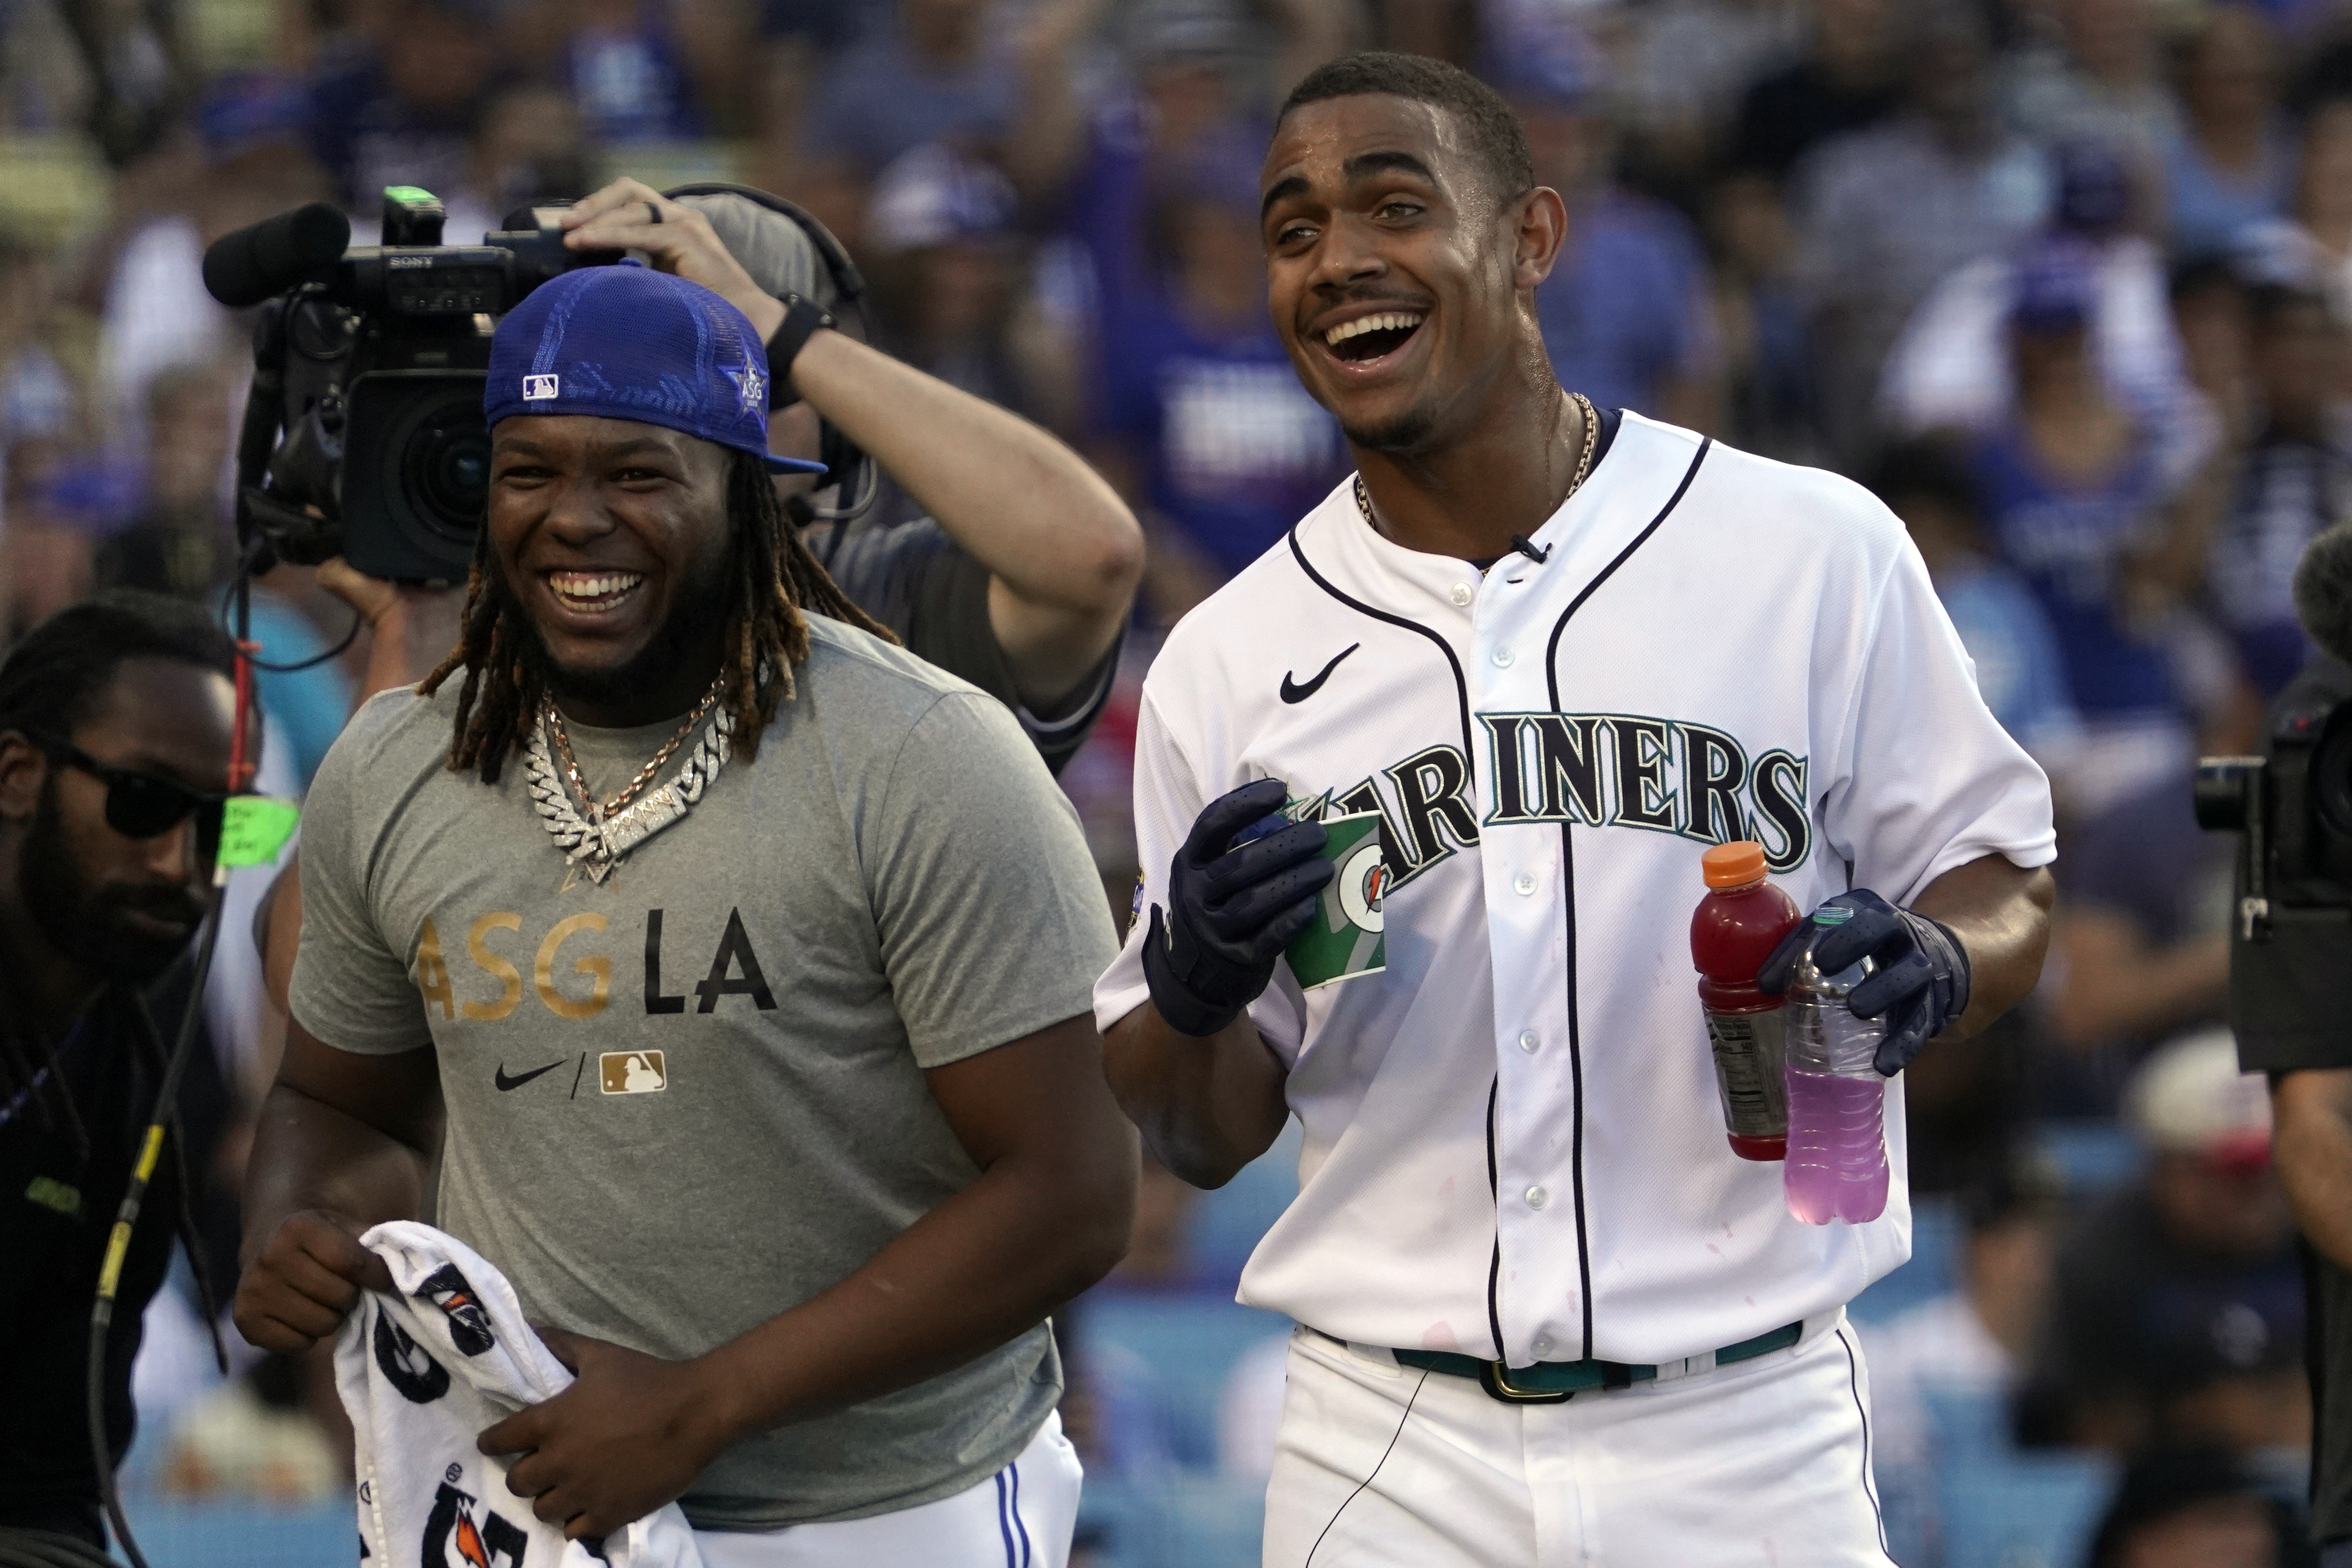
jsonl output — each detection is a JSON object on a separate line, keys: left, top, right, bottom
{"left": 0, "top": 593, "right": 251, "bottom": 1544}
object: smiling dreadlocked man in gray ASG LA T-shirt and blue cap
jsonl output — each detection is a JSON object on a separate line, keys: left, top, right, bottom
{"left": 237, "top": 266, "right": 1133, "bottom": 1568}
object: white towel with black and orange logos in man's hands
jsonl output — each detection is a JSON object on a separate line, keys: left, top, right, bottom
{"left": 334, "top": 1220, "right": 704, "bottom": 1568}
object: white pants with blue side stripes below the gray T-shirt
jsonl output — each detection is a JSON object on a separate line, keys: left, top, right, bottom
{"left": 694, "top": 1415, "right": 1082, "bottom": 1568}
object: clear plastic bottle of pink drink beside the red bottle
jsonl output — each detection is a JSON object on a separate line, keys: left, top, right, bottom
{"left": 1780, "top": 910, "right": 1886, "bottom": 1225}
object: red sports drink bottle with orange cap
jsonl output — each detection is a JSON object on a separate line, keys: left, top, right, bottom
{"left": 1691, "top": 839, "right": 1804, "bottom": 1159}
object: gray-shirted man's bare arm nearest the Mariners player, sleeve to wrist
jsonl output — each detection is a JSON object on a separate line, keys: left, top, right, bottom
{"left": 691, "top": 1016, "right": 1136, "bottom": 1436}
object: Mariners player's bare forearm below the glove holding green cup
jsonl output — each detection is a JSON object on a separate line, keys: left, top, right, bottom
{"left": 1103, "top": 1002, "right": 1292, "bottom": 1187}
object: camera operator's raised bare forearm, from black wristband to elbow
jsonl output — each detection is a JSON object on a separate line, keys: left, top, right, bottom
{"left": 793, "top": 331, "right": 1143, "bottom": 703}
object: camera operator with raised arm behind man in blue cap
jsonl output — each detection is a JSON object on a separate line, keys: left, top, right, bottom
{"left": 320, "top": 178, "right": 1143, "bottom": 771}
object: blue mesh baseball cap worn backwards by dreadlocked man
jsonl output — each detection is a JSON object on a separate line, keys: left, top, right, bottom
{"left": 482, "top": 256, "right": 825, "bottom": 472}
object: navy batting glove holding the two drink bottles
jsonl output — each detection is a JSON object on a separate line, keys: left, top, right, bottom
{"left": 1757, "top": 889, "right": 1969, "bottom": 1077}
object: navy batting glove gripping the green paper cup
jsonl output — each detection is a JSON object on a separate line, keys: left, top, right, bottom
{"left": 1143, "top": 778, "right": 1334, "bottom": 1037}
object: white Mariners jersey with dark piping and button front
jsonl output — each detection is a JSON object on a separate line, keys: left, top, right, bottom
{"left": 1096, "top": 414, "right": 2053, "bottom": 1366}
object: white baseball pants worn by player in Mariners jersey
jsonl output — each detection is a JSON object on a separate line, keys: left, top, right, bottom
{"left": 1265, "top": 1314, "right": 1891, "bottom": 1568}
